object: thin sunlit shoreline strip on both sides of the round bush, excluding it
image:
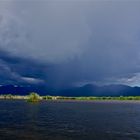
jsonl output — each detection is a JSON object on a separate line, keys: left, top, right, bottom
{"left": 0, "top": 94, "right": 140, "bottom": 101}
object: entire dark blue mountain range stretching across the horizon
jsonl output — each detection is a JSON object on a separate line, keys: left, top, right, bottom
{"left": 0, "top": 84, "right": 140, "bottom": 96}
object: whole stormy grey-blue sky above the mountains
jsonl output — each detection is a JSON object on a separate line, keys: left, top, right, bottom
{"left": 0, "top": 0, "right": 140, "bottom": 88}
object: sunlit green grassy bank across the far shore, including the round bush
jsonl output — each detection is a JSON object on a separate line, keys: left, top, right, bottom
{"left": 0, "top": 93, "right": 140, "bottom": 102}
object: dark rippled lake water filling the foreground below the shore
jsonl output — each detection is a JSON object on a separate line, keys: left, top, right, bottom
{"left": 0, "top": 100, "right": 140, "bottom": 140}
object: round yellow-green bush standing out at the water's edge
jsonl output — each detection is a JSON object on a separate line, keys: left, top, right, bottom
{"left": 27, "top": 92, "right": 40, "bottom": 102}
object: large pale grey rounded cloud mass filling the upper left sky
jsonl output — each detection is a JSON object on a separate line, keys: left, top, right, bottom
{"left": 0, "top": 1, "right": 90, "bottom": 63}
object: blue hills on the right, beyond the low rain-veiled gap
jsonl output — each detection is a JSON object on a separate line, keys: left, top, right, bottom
{"left": 59, "top": 85, "right": 133, "bottom": 96}
